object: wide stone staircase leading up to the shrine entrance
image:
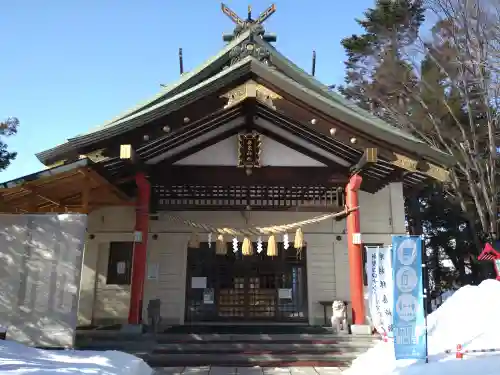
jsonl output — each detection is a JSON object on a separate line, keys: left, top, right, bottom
{"left": 76, "top": 331, "right": 378, "bottom": 368}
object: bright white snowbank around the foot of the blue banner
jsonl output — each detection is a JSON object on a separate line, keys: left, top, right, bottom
{"left": 343, "top": 280, "right": 500, "bottom": 375}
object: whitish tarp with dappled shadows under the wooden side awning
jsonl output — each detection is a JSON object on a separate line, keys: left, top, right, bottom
{"left": 0, "top": 214, "right": 87, "bottom": 347}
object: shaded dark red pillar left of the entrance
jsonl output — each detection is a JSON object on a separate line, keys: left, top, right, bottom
{"left": 128, "top": 172, "right": 151, "bottom": 324}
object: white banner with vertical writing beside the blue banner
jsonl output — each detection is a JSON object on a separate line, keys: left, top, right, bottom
{"left": 365, "top": 246, "right": 393, "bottom": 337}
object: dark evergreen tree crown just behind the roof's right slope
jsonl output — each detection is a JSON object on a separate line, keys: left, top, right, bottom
{"left": 339, "top": 0, "right": 424, "bottom": 116}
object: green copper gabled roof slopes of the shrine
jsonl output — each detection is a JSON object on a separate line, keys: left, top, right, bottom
{"left": 37, "top": 29, "right": 449, "bottom": 167}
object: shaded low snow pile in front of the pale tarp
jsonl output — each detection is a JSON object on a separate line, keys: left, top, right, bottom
{"left": 0, "top": 341, "right": 153, "bottom": 375}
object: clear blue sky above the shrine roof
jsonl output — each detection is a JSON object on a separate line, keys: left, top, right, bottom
{"left": 0, "top": 0, "right": 374, "bottom": 181}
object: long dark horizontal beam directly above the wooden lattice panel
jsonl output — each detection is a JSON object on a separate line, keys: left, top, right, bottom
{"left": 149, "top": 164, "right": 348, "bottom": 186}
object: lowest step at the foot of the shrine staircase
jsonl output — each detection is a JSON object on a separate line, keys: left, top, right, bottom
{"left": 134, "top": 353, "right": 356, "bottom": 367}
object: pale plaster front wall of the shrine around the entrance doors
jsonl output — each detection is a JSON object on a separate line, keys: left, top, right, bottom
{"left": 79, "top": 183, "right": 405, "bottom": 324}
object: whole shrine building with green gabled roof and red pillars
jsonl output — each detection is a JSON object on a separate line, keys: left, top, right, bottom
{"left": 0, "top": 5, "right": 454, "bottom": 326}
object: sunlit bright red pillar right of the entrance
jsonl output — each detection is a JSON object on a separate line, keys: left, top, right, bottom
{"left": 346, "top": 175, "right": 365, "bottom": 324}
